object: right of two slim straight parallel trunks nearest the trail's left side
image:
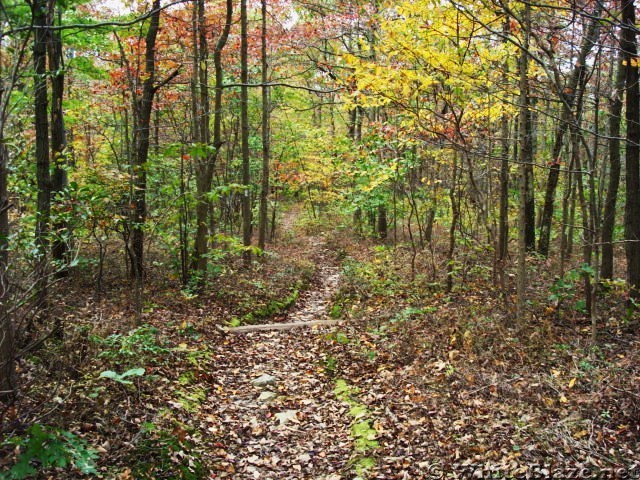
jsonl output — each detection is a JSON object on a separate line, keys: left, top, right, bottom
{"left": 258, "top": 0, "right": 271, "bottom": 250}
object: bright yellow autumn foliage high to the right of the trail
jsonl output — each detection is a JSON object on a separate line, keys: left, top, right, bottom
{"left": 344, "top": 0, "right": 516, "bottom": 143}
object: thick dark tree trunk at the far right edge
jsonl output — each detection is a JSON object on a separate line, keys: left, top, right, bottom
{"left": 620, "top": 0, "right": 640, "bottom": 300}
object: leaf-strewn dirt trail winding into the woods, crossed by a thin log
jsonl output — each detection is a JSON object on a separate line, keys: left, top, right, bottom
{"left": 201, "top": 213, "right": 353, "bottom": 480}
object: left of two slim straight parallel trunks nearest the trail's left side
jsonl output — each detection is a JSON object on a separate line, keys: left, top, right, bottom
{"left": 240, "top": 0, "right": 251, "bottom": 266}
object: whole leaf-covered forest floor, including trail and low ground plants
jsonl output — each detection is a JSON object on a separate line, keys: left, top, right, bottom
{"left": 0, "top": 204, "right": 640, "bottom": 480}
